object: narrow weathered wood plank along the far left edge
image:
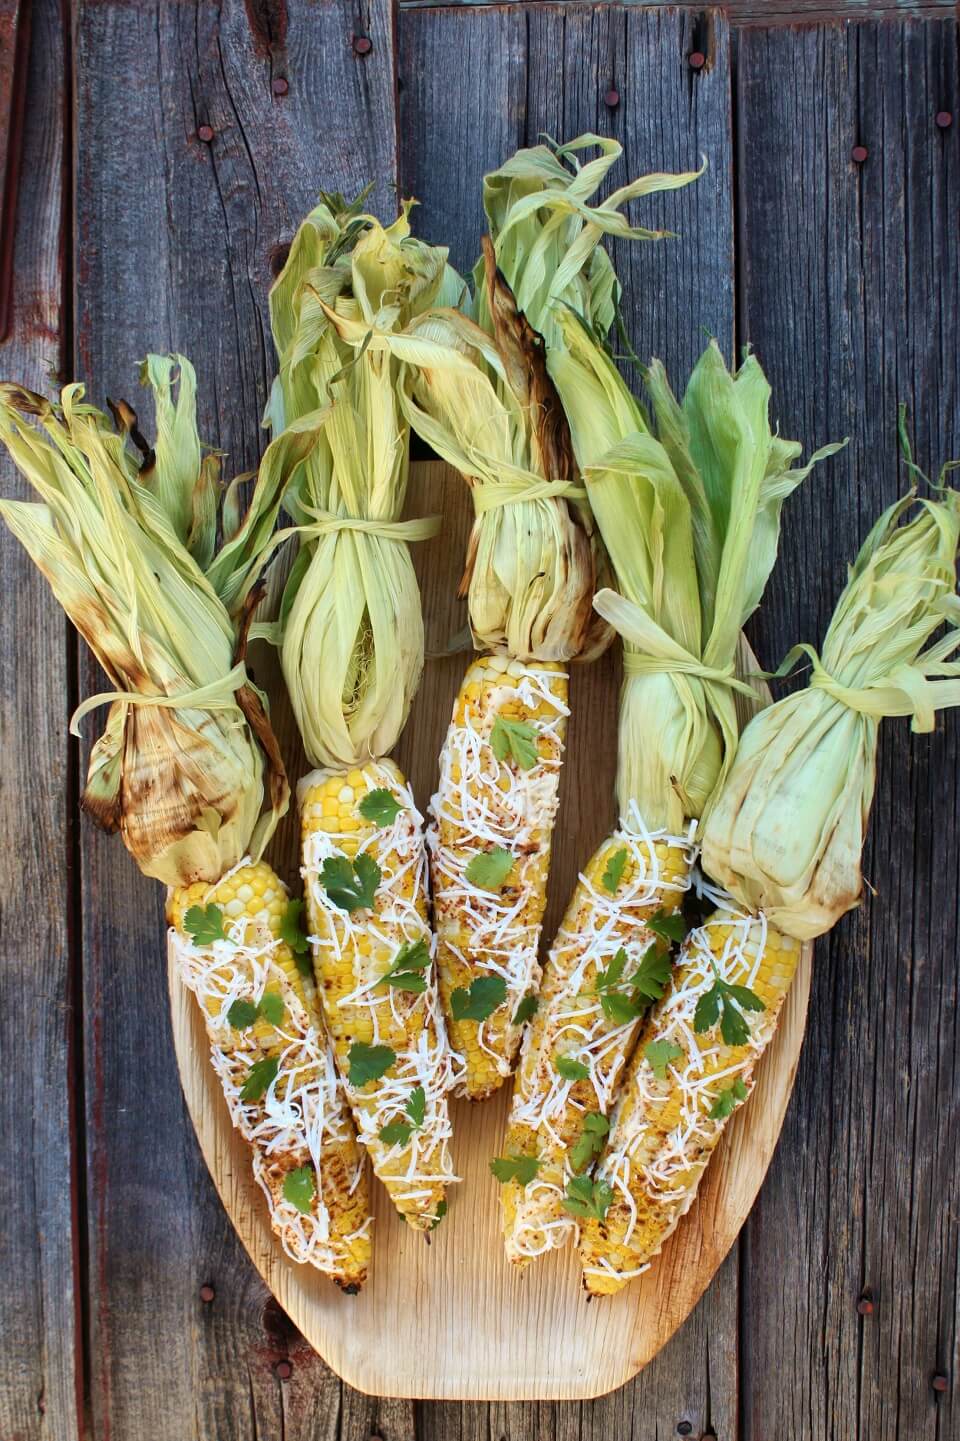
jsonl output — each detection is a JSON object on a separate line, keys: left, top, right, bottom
{"left": 0, "top": 0, "right": 82, "bottom": 1441}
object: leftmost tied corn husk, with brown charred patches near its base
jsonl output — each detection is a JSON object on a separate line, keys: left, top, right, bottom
{"left": 0, "top": 371, "right": 288, "bottom": 886}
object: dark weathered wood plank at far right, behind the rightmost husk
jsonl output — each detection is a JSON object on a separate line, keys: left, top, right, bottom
{"left": 737, "top": 20, "right": 960, "bottom": 1441}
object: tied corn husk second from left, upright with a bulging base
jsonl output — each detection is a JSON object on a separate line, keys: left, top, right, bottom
{"left": 264, "top": 196, "right": 463, "bottom": 769}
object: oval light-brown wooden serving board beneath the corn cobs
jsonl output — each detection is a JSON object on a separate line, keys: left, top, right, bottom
{"left": 169, "top": 464, "right": 812, "bottom": 1401}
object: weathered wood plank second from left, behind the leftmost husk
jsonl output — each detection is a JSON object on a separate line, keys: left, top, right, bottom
{"left": 75, "top": 0, "right": 396, "bottom": 1441}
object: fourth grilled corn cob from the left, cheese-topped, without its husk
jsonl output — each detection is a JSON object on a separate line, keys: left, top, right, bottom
{"left": 502, "top": 807, "right": 692, "bottom": 1265}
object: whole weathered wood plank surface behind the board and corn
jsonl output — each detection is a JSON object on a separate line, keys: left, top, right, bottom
{"left": 0, "top": 0, "right": 960, "bottom": 1441}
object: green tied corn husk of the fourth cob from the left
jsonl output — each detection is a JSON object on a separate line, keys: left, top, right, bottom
{"left": 554, "top": 321, "right": 836, "bottom": 834}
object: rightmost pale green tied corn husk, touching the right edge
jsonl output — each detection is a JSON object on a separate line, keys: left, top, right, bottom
{"left": 694, "top": 490, "right": 960, "bottom": 940}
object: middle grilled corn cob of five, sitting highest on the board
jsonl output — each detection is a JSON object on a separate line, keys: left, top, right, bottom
{"left": 428, "top": 656, "right": 569, "bottom": 1101}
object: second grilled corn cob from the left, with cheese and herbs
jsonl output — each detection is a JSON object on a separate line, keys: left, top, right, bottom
{"left": 300, "top": 761, "right": 458, "bottom": 1231}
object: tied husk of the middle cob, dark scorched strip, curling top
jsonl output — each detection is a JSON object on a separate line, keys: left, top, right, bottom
{"left": 327, "top": 135, "right": 695, "bottom": 661}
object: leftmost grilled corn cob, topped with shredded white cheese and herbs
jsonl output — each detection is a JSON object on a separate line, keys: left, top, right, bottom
{"left": 167, "top": 860, "right": 370, "bottom": 1293}
